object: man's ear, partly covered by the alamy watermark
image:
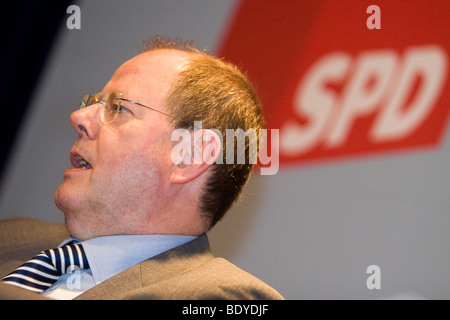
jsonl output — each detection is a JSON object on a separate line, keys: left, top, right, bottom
{"left": 170, "top": 129, "right": 222, "bottom": 183}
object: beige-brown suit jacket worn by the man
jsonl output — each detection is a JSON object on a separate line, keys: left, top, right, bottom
{"left": 0, "top": 218, "right": 283, "bottom": 300}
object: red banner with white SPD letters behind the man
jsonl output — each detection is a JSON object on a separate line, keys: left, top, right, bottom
{"left": 218, "top": 0, "right": 450, "bottom": 169}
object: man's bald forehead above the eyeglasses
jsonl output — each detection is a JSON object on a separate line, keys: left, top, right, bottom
{"left": 104, "top": 49, "right": 189, "bottom": 105}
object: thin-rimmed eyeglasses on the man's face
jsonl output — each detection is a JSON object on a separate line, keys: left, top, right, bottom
{"left": 80, "top": 91, "right": 187, "bottom": 125}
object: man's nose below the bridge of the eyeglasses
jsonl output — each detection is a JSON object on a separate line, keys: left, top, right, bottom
{"left": 70, "top": 103, "right": 100, "bottom": 139}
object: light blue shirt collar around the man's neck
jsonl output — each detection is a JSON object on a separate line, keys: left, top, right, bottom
{"left": 61, "top": 235, "right": 197, "bottom": 284}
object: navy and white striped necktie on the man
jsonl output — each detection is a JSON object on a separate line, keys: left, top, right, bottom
{"left": 2, "top": 243, "right": 89, "bottom": 293}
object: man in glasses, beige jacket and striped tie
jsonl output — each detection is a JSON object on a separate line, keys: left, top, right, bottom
{"left": 0, "top": 37, "right": 282, "bottom": 299}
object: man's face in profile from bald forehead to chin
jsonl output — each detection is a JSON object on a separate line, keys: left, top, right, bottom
{"left": 55, "top": 50, "right": 186, "bottom": 240}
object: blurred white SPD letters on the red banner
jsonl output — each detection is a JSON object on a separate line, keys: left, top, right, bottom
{"left": 280, "top": 45, "right": 447, "bottom": 156}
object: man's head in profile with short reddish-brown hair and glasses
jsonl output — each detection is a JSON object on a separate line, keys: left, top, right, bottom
{"left": 55, "top": 38, "right": 262, "bottom": 239}
